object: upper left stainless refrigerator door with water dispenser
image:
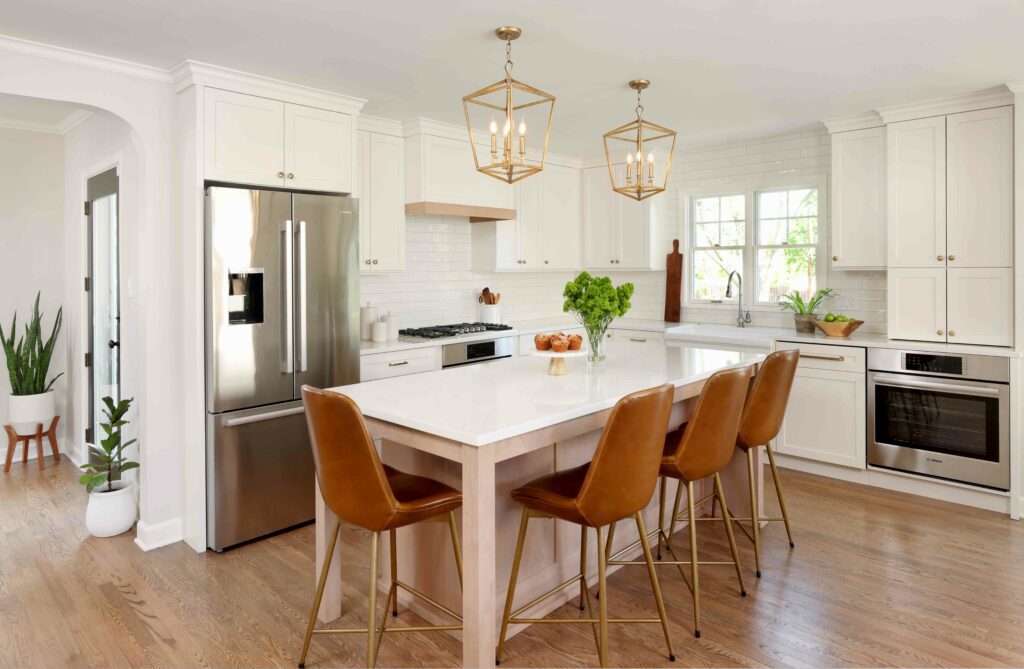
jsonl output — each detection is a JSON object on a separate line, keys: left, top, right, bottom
{"left": 206, "top": 187, "right": 292, "bottom": 413}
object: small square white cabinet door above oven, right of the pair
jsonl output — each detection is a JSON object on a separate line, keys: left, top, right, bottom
{"left": 946, "top": 267, "right": 1014, "bottom": 346}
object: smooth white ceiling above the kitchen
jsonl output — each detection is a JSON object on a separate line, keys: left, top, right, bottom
{"left": 0, "top": 0, "right": 1024, "bottom": 155}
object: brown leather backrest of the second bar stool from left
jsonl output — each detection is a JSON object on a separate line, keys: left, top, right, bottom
{"left": 577, "top": 383, "right": 675, "bottom": 528}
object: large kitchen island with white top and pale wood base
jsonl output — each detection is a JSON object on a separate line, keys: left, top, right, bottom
{"left": 316, "top": 342, "right": 763, "bottom": 667}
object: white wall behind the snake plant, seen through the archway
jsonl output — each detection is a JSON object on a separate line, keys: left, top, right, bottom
{"left": 0, "top": 128, "right": 68, "bottom": 440}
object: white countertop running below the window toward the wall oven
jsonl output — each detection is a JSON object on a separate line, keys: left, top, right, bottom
{"left": 665, "top": 323, "right": 1021, "bottom": 358}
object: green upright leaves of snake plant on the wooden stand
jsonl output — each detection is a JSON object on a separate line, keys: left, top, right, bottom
{"left": 0, "top": 293, "right": 63, "bottom": 395}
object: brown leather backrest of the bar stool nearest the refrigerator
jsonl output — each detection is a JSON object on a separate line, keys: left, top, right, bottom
{"left": 302, "top": 385, "right": 398, "bottom": 529}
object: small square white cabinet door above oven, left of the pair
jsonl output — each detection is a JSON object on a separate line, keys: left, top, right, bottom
{"left": 888, "top": 267, "right": 946, "bottom": 341}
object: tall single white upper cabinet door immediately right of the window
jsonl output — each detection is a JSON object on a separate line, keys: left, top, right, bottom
{"left": 831, "top": 128, "right": 886, "bottom": 268}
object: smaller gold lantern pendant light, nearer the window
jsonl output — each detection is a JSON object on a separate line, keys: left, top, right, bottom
{"left": 604, "top": 79, "right": 676, "bottom": 200}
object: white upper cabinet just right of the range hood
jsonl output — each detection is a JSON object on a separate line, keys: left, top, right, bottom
{"left": 472, "top": 163, "right": 581, "bottom": 271}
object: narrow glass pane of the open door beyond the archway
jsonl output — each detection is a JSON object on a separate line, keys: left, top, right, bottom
{"left": 91, "top": 193, "right": 121, "bottom": 440}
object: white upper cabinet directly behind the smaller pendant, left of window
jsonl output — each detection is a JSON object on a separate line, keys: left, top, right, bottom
{"left": 583, "top": 167, "right": 668, "bottom": 270}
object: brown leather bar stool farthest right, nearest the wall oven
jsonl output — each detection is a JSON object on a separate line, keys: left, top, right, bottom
{"left": 713, "top": 348, "right": 800, "bottom": 578}
